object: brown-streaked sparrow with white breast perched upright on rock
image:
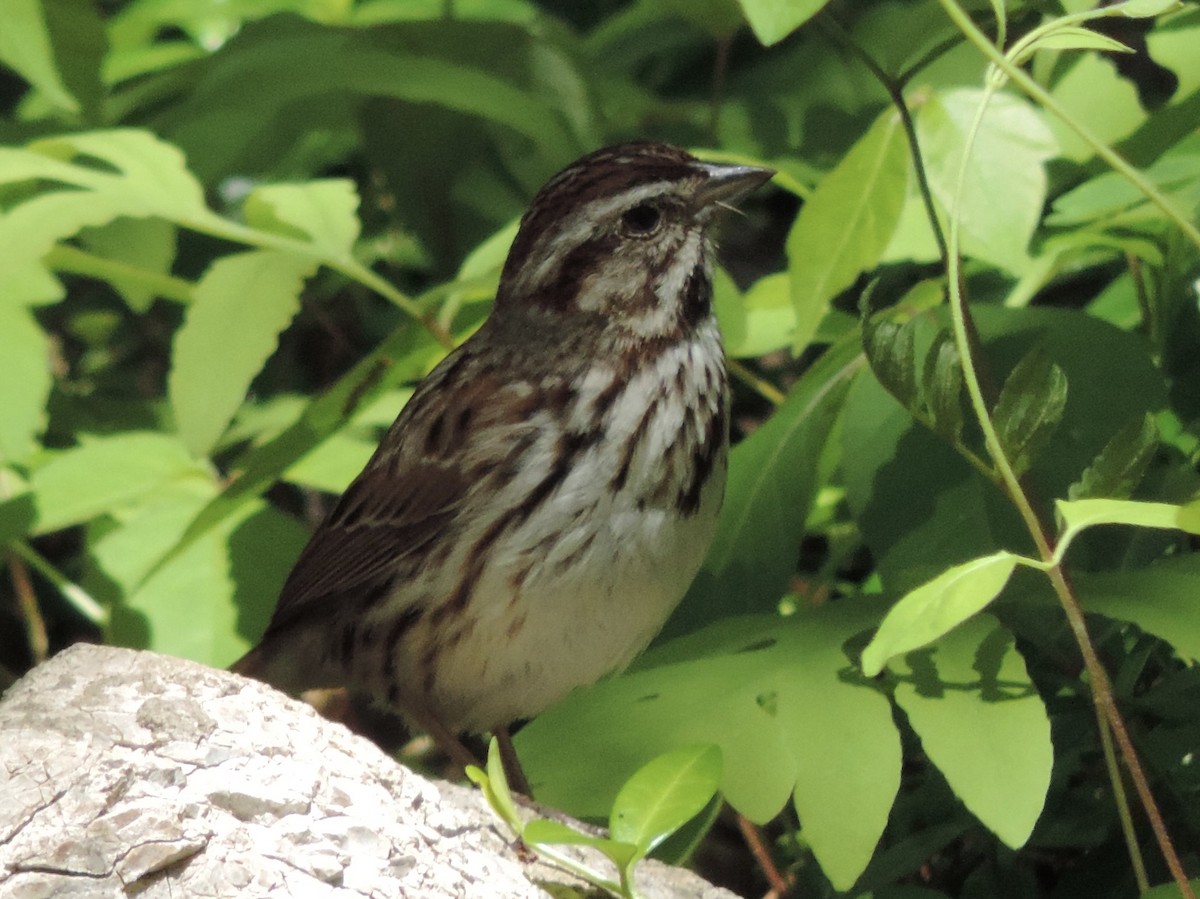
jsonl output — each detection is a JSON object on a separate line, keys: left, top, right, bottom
{"left": 234, "top": 143, "right": 772, "bottom": 760}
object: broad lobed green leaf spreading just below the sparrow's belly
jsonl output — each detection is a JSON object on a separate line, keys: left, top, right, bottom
{"left": 516, "top": 599, "right": 900, "bottom": 889}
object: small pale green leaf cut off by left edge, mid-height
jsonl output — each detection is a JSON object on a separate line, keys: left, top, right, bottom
{"left": 0, "top": 304, "right": 52, "bottom": 465}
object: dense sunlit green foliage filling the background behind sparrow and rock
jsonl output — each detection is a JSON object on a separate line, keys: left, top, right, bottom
{"left": 0, "top": 0, "right": 1200, "bottom": 899}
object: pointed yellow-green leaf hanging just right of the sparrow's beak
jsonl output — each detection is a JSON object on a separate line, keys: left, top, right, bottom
{"left": 787, "top": 110, "right": 908, "bottom": 350}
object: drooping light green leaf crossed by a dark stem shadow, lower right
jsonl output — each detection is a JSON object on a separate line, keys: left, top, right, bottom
{"left": 889, "top": 615, "right": 1054, "bottom": 849}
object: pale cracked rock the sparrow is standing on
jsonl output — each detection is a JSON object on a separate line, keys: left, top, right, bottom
{"left": 0, "top": 645, "right": 733, "bottom": 899}
